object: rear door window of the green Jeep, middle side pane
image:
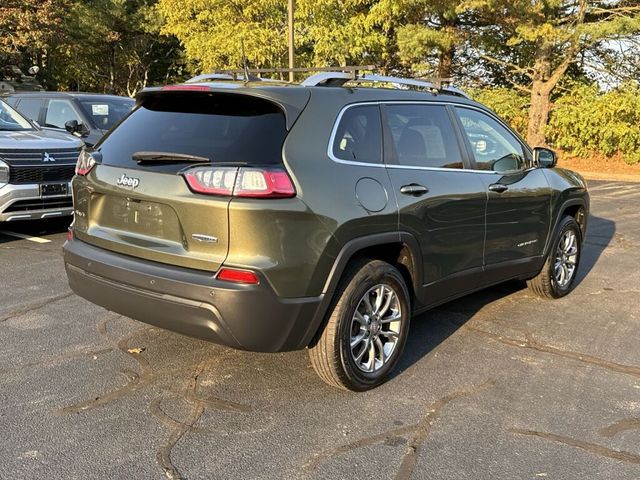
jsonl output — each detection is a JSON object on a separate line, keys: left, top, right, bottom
{"left": 385, "top": 105, "right": 463, "bottom": 168}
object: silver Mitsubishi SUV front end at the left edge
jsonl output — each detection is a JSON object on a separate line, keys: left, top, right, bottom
{"left": 0, "top": 100, "right": 83, "bottom": 222}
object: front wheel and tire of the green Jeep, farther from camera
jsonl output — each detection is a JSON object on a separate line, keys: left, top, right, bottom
{"left": 527, "top": 216, "right": 582, "bottom": 298}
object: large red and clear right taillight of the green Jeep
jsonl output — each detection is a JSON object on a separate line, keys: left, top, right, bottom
{"left": 183, "top": 167, "right": 296, "bottom": 198}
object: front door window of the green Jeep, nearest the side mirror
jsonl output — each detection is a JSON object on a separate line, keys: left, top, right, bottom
{"left": 456, "top": 107, "right": 525, "bottom": 173}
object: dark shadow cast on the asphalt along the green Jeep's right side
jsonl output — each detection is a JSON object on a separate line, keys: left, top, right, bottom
{"left": 392, "top": 216, "right": 616, "bottom": 377}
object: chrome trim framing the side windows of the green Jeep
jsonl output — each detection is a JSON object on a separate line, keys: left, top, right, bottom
{"left": 327, "top": 100, "right": 535, "bottom": 176}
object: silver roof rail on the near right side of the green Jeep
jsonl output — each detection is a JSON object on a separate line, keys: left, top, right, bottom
{"left": 302, "top": 72, "right": 469, "bottom": 98}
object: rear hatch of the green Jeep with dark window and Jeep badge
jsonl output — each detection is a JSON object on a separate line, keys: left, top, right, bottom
{"left": 74, "top": 90, "right": 300, "bottom": 271}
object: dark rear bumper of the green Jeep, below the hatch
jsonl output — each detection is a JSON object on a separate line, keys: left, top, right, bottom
{"left": 63, "top": 239, "right": 322, "bottom": 352}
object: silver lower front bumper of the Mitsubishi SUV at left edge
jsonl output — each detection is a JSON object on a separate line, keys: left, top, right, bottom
{"left": 0, "top": 183, "right": 73, "bottom": 222}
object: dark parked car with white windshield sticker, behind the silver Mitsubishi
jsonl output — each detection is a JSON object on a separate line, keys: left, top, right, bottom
{"left": 6, "top": 92, "right": 135, "bottom": 146}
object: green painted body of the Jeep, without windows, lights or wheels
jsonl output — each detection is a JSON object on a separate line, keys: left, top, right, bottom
{"left": 64, "top": 84, "right": 589, "bottom": 351}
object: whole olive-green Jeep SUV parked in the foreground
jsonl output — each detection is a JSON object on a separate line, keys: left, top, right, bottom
{"left": 64, "top": 72, "right": 589, "bottom": 390}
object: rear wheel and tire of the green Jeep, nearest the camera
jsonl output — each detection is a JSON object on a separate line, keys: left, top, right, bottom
{"left": 309, "top": 259, "right": 411, "bottom": 391}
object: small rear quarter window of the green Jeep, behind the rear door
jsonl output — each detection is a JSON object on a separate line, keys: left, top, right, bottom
{"left": 332, "top": 105, "right": 382, "bottom": 163}
